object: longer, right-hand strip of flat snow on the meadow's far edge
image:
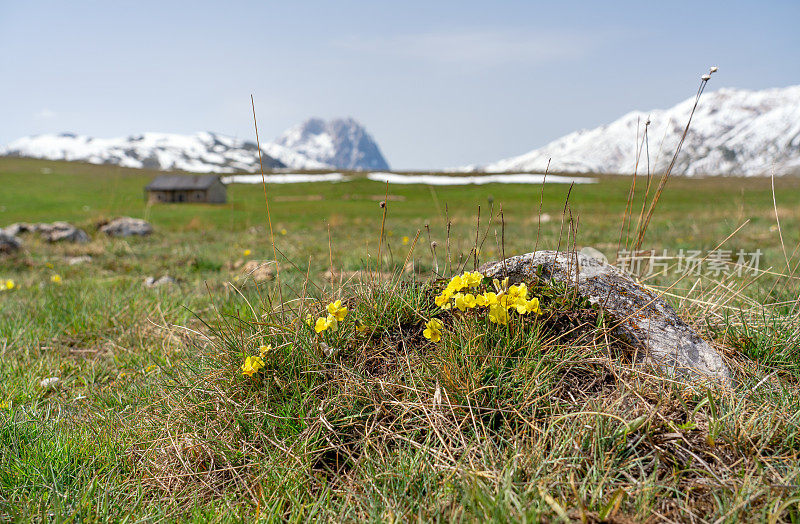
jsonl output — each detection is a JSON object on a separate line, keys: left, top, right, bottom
{"left": 367, "top": 172, "right": 597, "bottom": 186}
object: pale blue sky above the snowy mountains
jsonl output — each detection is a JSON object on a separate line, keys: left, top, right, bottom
{"left": 0, "top": 0, "right": 800, "bottom": 169}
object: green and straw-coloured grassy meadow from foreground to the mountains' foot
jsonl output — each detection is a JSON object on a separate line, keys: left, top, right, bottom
{"left": 0, "top": 158, "right": 800, "bottom": 522}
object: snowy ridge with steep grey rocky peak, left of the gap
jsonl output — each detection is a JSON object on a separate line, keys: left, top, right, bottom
{"left": 0, "top": 119, "right": 388, "bottom": 173}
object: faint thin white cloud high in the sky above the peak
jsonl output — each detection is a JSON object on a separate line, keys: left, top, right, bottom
{"left": 333, "top": 30, "right": 597, "bottom": 67}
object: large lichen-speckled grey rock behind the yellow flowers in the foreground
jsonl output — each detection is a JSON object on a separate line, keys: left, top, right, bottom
{"left": 479, "top": 251, "right": 732, "bottom": 385}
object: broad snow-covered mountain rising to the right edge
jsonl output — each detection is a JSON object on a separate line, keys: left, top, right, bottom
{"left": 472, "top": 86, "right": 800, "bottom": 176}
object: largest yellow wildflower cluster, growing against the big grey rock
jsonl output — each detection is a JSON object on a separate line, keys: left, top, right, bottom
{"left": 435, "top": 271, "right": 542, "bottom": 324}
